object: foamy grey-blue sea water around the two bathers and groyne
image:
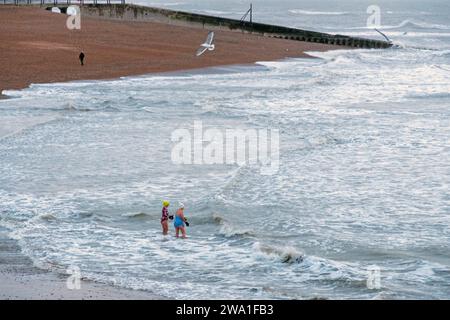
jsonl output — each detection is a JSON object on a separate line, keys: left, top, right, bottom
{"left": 0, "top": 0, "right": 450, "bottom": 299}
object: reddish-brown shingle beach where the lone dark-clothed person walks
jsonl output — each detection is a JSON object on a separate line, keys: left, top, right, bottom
{"left": 0, "top": 6, "right": 342, "bottom": 93}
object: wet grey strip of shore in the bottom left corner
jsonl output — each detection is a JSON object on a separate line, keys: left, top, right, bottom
{"left": 0, "top": 227, "right": 167, "bottom": 300}
